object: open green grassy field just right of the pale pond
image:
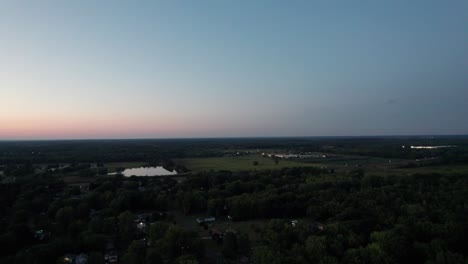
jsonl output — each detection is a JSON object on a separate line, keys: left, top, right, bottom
{"left": 175, "top": 156, "right": 320, "bottom": 172}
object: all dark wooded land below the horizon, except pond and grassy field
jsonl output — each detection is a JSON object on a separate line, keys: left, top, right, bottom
{"left": 0, "top": 137, "right": 468, "bottom": 264}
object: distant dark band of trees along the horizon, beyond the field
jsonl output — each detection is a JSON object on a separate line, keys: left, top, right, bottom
{"left": 0, "top": 136, "right": 468, "bottom": 165}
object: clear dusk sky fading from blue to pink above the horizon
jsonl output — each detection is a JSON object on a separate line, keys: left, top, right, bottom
{"left": 0, "top": 0, "right": 468, "bottom": 140}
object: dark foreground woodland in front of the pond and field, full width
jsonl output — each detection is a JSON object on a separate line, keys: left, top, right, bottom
{"left": 0, "top": 165, "right": 468, "bottom": 264}
